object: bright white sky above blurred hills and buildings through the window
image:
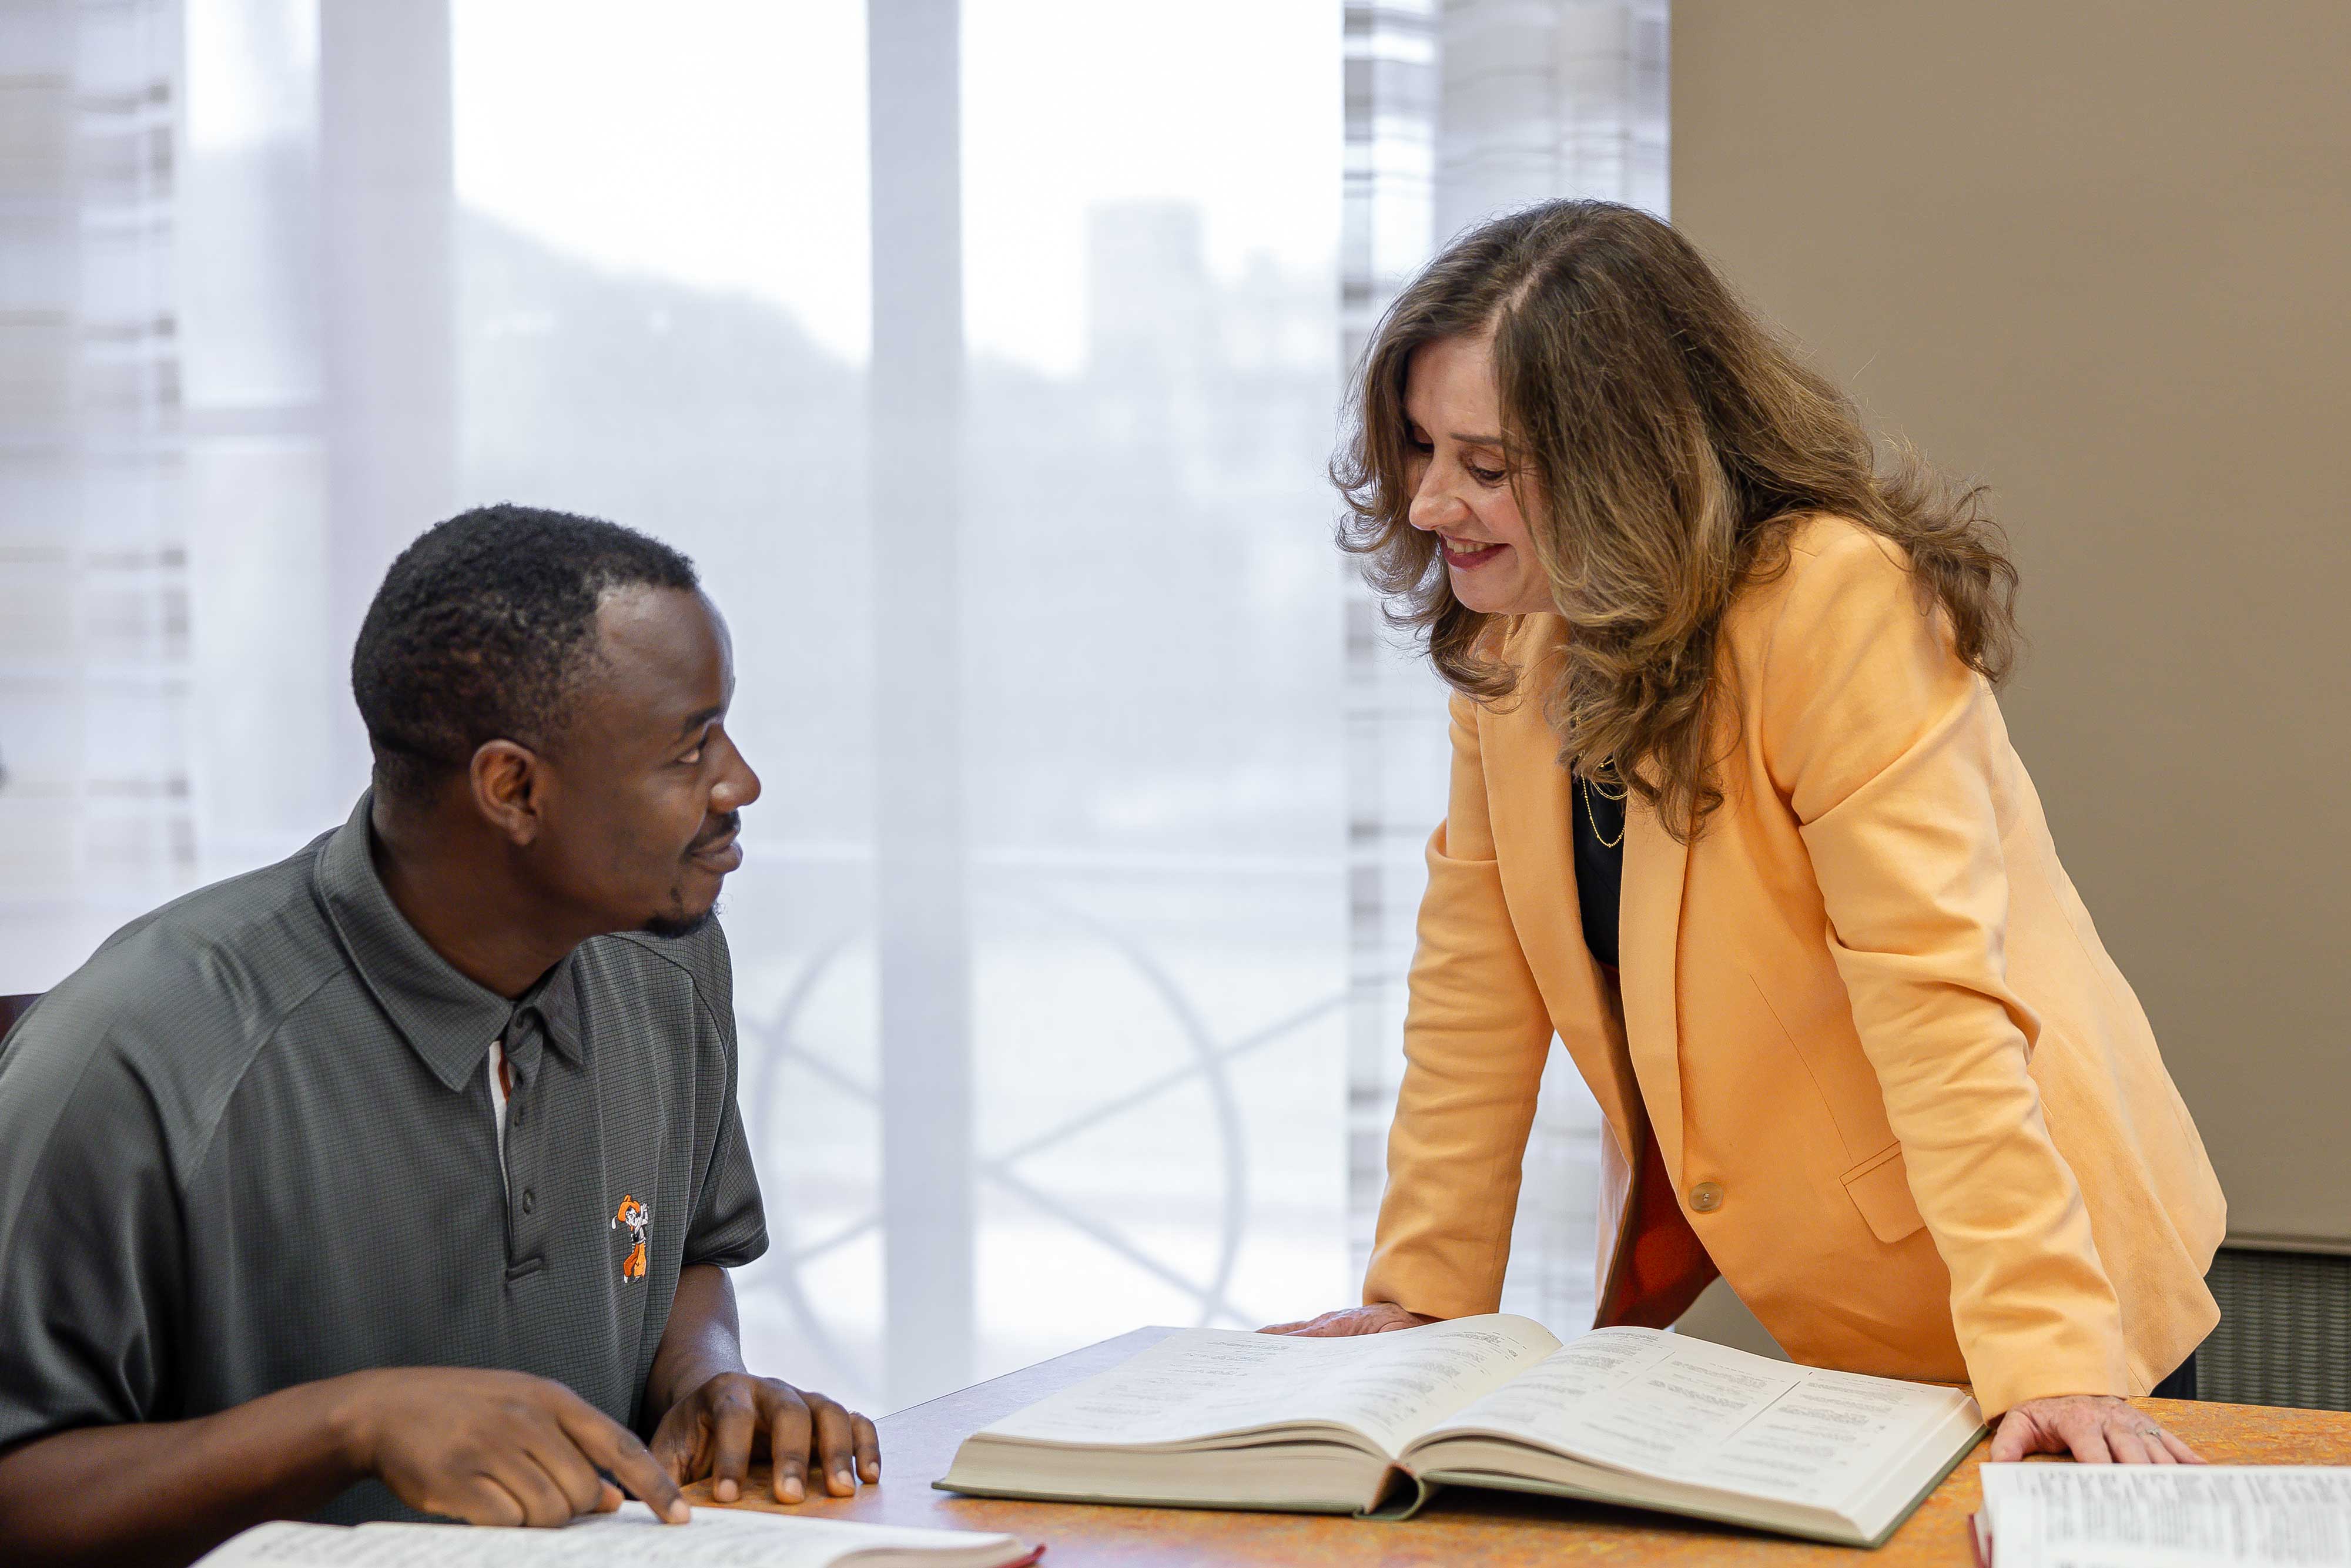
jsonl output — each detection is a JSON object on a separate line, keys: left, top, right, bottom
{"left": 451, "top": 0, "right": 1340, "bottom": 376}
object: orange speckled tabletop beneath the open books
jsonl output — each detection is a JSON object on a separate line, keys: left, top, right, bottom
{"left": 686, "top": 1328, "right": 2351, "bottom": 1568}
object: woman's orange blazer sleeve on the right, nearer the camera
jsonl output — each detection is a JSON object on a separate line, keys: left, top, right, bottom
{"left": 1761, "top": 531, "right": 2130, "bottom": 1415}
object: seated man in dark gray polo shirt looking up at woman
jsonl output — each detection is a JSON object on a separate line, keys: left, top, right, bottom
{"left": 0, "top": 505, "right": 879, "bottom": 1563}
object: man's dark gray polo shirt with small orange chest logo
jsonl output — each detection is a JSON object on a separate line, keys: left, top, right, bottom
{"left": 0, "top": 799, "right": 766, "bottom": 1519}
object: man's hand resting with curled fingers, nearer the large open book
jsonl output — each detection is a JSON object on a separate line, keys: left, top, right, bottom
{"left": 654, "top": 1373, "right": 882, "bottom": 1502}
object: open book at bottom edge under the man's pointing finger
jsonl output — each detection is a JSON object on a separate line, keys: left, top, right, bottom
{"left": 195, "top": 1502, "right": 1039, "bottom": 1568}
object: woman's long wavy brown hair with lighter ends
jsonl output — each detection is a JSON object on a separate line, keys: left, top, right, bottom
{"left": 1331, "top": 202, "right": 2017, "bottom": 842}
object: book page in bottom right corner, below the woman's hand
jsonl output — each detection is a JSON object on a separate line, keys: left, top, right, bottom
{"left": 1984, "top": 1465, "right": 2351, "bottom": 1568}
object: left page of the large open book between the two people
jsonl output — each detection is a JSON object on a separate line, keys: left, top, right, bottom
{"left": 983, "top": 1314, "right": 1559, "bottom": 1455}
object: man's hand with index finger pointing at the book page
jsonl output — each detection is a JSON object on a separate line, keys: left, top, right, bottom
{"left": 331, "top": 1366, "right": 694, "bottom": 1526}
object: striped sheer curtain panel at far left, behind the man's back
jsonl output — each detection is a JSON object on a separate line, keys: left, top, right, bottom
{"left": 0, "top": 0, "right": 195, "bottom": 990}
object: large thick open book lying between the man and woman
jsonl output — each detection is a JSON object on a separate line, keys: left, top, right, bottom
{"left": 938, "top": 1314, "right": 1982, "bottom": 1547}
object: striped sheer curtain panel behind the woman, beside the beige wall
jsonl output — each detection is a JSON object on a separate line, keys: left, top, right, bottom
{"left": 1342, "top": 0, "right": 1669, "bottom": 1326}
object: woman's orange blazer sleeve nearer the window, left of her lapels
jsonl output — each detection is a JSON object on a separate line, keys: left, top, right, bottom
{"left": 1364, "top": 696, "right": 1552, "bottom": 1316}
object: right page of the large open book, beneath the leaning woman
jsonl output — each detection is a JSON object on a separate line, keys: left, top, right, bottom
{"left": 1429, "top": 1328, "right": 1970, "bottom": 1507}
